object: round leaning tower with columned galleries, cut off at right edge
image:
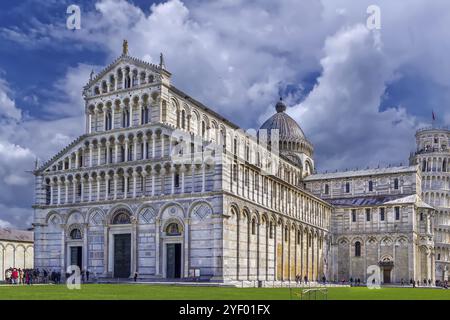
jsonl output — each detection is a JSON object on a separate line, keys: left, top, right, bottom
{"left": 410, "top": 127, "right": 450, "bottom": 281}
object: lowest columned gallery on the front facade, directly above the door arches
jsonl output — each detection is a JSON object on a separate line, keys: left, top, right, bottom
{"left": 44, "top": 163, "right": 211, "bottom": 205}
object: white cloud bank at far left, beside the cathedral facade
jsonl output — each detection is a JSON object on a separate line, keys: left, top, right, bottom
{"left": 0, "top": 69, "right": 90, "bottom": 228}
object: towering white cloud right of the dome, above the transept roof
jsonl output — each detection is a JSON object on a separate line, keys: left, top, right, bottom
{"left": 289, "top": 25, "right": 417, "bottom": 169}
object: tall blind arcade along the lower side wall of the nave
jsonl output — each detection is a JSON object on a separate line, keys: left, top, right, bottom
{"left": 228, "top": 208, "right": 327, "bottom": 281}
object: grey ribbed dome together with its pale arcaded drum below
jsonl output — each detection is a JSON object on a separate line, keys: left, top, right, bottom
{"left": 258, "top": 98, "right": 314, "bottom": 176}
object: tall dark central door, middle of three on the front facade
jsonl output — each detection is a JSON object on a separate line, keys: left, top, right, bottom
{"left": 114, "top": 234, "right": 131, "bottom": 278}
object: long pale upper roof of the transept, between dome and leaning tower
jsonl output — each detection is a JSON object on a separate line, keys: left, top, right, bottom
{"left": 305, "top": 166, "right": 417, "bottom": 181}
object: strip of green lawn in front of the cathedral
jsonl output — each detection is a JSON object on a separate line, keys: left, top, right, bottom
{"left": 0, "top": 284, "right": 450, "bottom": 300}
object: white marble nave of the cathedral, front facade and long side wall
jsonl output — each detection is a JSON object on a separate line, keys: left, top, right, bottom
{"left": 34, "top": 43, "right": 331, "bottom": 284}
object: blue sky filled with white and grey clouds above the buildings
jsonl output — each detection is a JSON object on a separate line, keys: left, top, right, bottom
{"left": 0, "top": 0, "right": 450, "bottom": 228}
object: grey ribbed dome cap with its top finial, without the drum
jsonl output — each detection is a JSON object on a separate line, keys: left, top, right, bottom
{"left": 260, "top": 98, "right": 306, "bottom": 141}
